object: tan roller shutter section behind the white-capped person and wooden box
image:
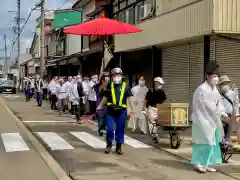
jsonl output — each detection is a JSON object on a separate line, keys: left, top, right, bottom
{"left": 163, "top": 45, "right": 189, "bottom": 103}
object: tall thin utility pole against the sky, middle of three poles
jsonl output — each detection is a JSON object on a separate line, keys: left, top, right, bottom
{"left": 17, "top": 0, "right": 21, "bottom": 90}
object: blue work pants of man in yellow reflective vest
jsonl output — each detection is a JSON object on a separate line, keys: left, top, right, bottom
{"left": 106, "top": 110, "right": 127, "bottom": 145}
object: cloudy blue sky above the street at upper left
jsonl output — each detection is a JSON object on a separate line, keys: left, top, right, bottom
{"left": 0, "top": 0, "right": 76, "bottom": 63}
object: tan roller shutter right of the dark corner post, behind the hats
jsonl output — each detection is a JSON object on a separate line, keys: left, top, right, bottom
{"left": 215, "top": 39, "right": 240, "bottom": 88}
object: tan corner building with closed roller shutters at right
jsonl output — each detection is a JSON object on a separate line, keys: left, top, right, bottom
{"left": 112, "top": 0, "right": 240, "bottom": 105}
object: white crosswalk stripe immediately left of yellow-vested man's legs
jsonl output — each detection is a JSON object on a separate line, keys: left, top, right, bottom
{"left": 69, "top": 132, "right": 106, "bottom": 149}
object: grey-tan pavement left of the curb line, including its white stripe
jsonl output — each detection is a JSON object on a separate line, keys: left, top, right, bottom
{"left": 0, "top": 97, "right": 69, "bottom": 180}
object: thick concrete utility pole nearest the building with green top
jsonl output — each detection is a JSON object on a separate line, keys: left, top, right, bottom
{"left": 40, "top": 0, "right": 45, "bottom": 78}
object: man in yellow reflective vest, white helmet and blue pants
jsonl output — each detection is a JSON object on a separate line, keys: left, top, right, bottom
{"left": 97, "top": 68, "right": 133, "bottom": 155}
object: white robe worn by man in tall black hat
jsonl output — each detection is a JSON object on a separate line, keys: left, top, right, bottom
{"left": 191, "top": 82, "right": 224, "bottom": 145}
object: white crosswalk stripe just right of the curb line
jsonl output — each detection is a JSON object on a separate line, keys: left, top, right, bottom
{"left": 37, "top": 132, "right": 74, "bottom": 150}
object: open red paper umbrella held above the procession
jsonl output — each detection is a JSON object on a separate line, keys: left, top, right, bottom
{"left": 64, "top": 15, "right": 142, "bottom": 36}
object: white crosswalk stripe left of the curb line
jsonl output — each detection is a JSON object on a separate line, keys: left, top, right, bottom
{"left": 1, "top": 133, "right": 29, "bottom": 152}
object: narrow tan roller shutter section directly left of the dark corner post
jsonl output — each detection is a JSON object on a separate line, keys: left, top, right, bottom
{"left": 189, "top": 43, "right": 204, "bottom": 106}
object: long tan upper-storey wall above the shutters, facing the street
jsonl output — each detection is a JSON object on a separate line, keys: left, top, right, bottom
{"left": 115, "top": 0, "right": 213, "bottom": 52}
